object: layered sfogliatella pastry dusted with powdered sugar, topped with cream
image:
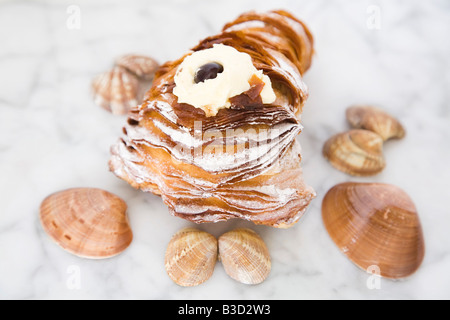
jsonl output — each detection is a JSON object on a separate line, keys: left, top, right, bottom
{"left": 110, "top": 11, "right": 315, "bottom": 228}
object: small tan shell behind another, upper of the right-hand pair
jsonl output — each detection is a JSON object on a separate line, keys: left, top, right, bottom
{"left": 346, "top": 106, "right": 405, "bottom": 141}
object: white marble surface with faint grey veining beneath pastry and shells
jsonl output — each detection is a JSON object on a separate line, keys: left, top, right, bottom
{"left": 0, "top": 0, "right": 450, "bottom": 299}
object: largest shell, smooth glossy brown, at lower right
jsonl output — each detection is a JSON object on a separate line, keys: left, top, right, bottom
{"left": 322, "top": 182, "right": 425, "bottom": 279}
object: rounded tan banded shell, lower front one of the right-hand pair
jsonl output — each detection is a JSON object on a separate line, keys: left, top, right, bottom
{"left": 323, "top": 129, "right": 386, "bottom": 176}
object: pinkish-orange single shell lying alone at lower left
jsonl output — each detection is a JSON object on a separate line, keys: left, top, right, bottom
{"left": 40, "top": 188, "right": 133, "bottom": 259}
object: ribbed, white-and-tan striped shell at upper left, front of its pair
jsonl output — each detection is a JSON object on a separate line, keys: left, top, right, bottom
{"left": 92, "top": 66, "right": 140, "bottom": 115}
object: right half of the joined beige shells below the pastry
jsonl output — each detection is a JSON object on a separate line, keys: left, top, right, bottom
{"left": 219, "top": 229, "right": 271, "bottom": 284}
